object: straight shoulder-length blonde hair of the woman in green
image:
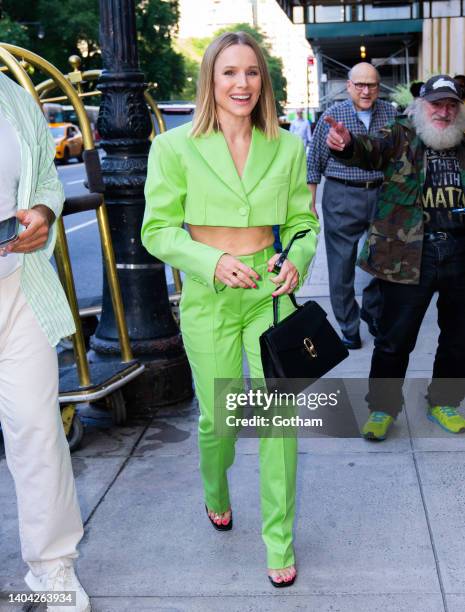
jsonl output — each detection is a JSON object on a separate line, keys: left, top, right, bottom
{"left": 191, "top": 32, "right": 279, "bottom": 139}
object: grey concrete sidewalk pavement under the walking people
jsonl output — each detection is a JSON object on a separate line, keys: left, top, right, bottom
{"left": 0, "top": 188, "right": 465, "bottom": 612}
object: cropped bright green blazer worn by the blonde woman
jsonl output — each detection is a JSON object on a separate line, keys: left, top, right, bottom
{"left": 142, "top": 123, "right": 319, "bottom": 290}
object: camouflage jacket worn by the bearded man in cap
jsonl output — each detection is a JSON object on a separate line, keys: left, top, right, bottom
{"left": 332, "top": 115, "right": 465, "bottom": 285}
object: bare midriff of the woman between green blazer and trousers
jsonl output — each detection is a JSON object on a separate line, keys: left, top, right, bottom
{"left": 187, "top": 225, "right": 274, "bottom": 257}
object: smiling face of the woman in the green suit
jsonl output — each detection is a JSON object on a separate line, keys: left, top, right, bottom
{"left": 213, "top": 45, "right": 262, "bottom": 121}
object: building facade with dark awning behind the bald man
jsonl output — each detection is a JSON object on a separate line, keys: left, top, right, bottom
{"left": 276, "top": 0, "right": 465, "bottom": 109}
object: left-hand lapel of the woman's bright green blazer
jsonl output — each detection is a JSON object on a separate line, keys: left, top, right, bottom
{"left": 191, "top": 132, "right": 247, "bottom": 201}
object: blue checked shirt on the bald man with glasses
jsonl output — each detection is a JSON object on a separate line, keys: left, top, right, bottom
{"left": 307, "top": 100, "right": 397, "bottom": 184}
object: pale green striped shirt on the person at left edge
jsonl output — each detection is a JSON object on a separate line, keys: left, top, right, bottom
{"left": 0, "top": 73, "right": 75, "bottom": 346}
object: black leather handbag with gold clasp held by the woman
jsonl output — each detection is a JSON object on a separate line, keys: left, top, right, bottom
{"left": 260, "top": 230, "right": 349, "bottom": 391}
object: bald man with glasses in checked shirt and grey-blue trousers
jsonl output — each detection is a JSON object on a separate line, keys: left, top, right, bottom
{"left": 307, "top": 62, "right": 396, "bottom": 349}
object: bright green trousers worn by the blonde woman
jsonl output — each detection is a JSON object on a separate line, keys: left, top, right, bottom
{"left": 180, "top": 247, "right": 297, "bottom": 569}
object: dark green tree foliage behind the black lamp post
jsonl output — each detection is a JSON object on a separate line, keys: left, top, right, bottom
{"left": 0, "top": 0, "right": 185, "bottom": 99}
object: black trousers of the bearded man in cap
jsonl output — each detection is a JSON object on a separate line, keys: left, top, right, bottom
{"left": 367, "top": 238, "right": 465, "bottom": 417}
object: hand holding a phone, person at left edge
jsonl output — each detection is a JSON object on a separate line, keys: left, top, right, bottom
{"left": 5, "top": 205, "right": 54, "bottom": 253}
